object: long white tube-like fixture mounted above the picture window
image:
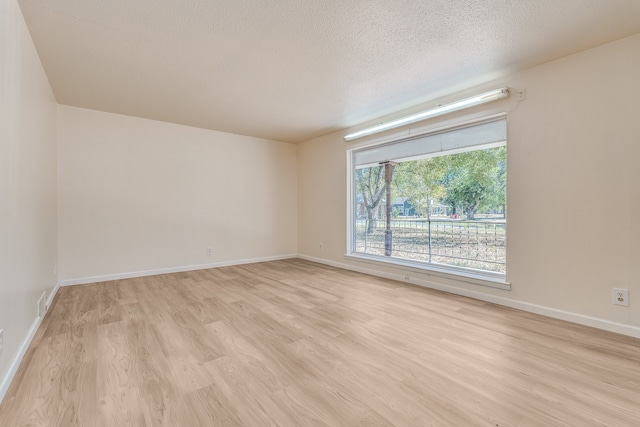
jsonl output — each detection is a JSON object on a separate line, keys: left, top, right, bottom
{"left": 344, "top": 87, "right": 509, "bottom": 141}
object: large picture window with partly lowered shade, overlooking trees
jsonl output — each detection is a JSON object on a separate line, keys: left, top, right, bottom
{"left": 349, "top": 118, "right": 507, "bottom": 278}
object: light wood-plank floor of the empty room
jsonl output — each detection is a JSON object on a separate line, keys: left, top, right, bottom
{"left": 0, "top": 260, "right": 640, "bottom": 427}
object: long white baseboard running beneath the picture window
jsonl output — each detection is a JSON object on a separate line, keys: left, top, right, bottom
{"left": 298, "top": 254, "right": 640, "bottom": 338}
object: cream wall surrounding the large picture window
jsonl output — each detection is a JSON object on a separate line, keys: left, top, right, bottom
{"left": 298, "top": 35, "right": 640, "bottom": 336}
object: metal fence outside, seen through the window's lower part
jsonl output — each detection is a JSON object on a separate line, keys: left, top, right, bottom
{"left": 355, "top": 219, "right": 507, "bottom": 273}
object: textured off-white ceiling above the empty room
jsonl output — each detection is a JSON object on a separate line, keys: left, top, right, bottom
{"left": 20, "top": 0, "right": 640, "bottom": 142}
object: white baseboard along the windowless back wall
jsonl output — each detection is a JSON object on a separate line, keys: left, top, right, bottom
{"left": 60, "top": 254, "right": 297, "bottom": 286}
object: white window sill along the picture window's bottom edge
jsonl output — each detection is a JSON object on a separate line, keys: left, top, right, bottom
{"left": 344, "top": 254, "right": 511, "bottom": 291}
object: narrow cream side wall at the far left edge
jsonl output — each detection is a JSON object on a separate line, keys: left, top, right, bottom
{"left": 0, "top": 0, "right": 57, "bottom": 388}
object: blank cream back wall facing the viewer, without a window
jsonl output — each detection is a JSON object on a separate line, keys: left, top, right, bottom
{"left": 58, "top": 105, "right": 297, "bottom": 283}
